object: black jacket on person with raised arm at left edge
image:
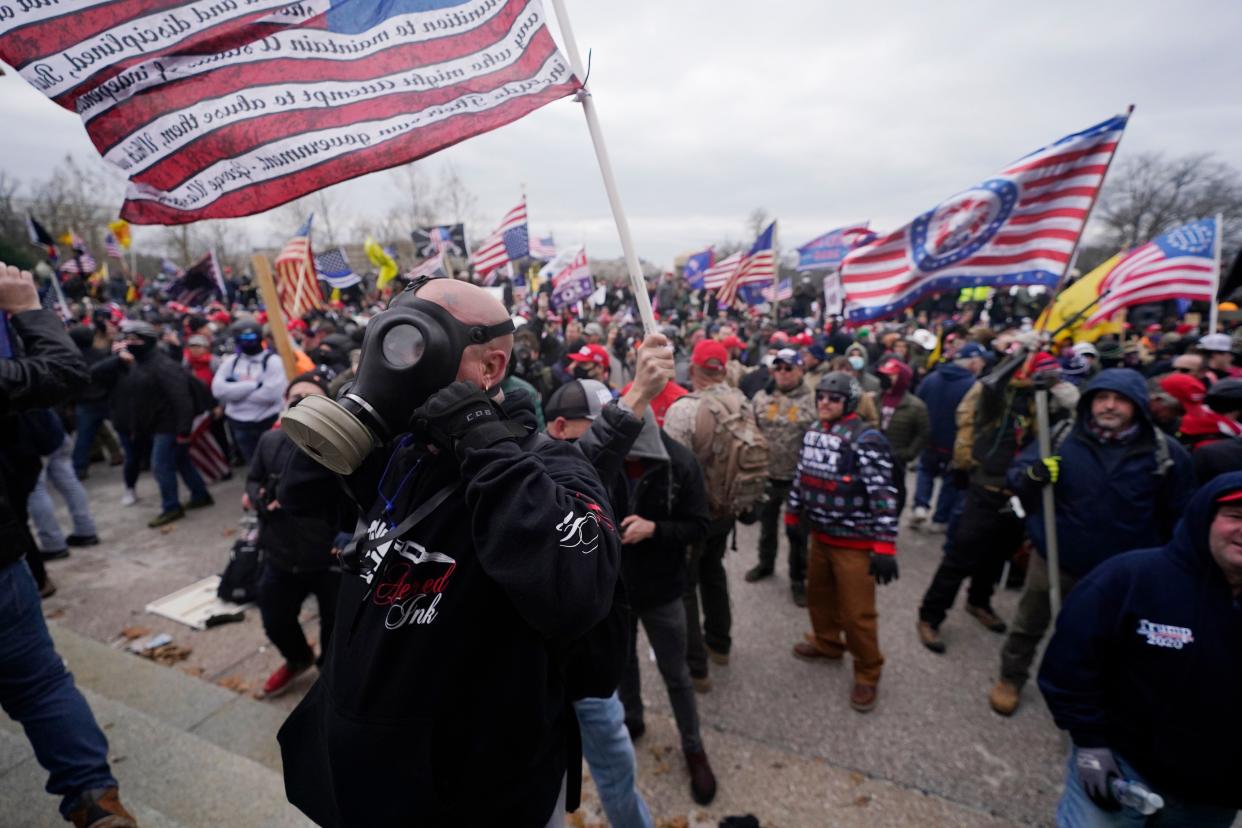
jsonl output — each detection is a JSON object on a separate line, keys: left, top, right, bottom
{"left": 0, "top": 310, "right": 88, "bottom": 566}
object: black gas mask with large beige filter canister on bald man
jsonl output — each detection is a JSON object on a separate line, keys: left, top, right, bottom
{"left": 281, "top": 279, "right": 513, "bottom": 474}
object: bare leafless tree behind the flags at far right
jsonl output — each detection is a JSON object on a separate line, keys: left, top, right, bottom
{"left": 1093, "top": 153, "right": 1242, "bottom": 250}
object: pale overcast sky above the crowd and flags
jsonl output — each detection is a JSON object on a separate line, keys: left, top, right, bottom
{"left": 0, "top": 0, "right": 1242, "bottom": 264}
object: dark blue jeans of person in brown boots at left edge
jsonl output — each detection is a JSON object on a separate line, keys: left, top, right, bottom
{"left": 0, "top": 561, "right": 117, "bottom": 816}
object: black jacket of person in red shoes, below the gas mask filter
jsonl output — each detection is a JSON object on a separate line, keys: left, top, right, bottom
{"left": 246, "top": 428, "right": 355, "bottom": 572}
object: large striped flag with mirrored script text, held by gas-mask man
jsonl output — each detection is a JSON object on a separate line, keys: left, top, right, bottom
{"left": 0, "top": 0, "right": 580, "bottom": 225}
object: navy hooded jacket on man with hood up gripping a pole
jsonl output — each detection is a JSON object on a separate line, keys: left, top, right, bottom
{"left": 1009, "top": 367, "right": 1195, "bottom": 576}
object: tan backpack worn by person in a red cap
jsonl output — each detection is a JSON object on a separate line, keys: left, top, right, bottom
{"left": 692, "top": 391, "right": 768, "bottom": 518}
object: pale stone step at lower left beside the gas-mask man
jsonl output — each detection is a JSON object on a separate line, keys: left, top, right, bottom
{"left": 0, "top": 624, "right": 312, "bottom": 828}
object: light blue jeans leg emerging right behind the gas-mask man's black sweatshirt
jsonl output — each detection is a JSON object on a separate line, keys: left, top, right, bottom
{"left": 574, "top": 693, "right": 652, "bottom": 828}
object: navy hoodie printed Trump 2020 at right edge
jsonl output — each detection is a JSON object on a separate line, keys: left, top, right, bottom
{"left": 1040, "top": 472, "right": 1242, "bottom": 808}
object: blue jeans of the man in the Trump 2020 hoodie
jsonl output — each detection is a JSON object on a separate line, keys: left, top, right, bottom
{"left": 1057, "top": 747, "right": 1237, "bottom": 828}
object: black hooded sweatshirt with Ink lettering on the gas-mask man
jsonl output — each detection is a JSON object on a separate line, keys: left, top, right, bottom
{"left": 279, "top": 395, "right": 620, "bottom": 828}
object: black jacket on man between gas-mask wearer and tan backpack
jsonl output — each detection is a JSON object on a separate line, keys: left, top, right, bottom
{"left": 621, "top": 423, "right": 712, "bottom": 611}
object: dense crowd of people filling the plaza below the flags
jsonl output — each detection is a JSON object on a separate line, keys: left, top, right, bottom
{"left": 0, "top": 260, "right": 1242, "bottom": 828}
